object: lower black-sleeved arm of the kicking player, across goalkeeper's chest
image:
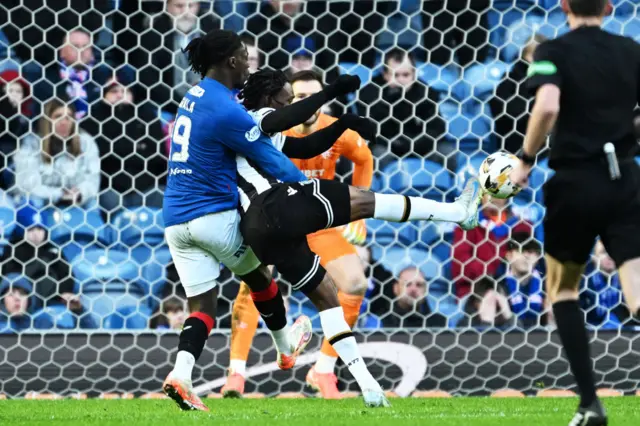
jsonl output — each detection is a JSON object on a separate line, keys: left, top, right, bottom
{"left": 282, "top": 113, "right": 375, "bottom": 160}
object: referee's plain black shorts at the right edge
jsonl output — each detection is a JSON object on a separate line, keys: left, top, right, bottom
{"left": 544, "top": 162, "right": 640, "bottom": 266}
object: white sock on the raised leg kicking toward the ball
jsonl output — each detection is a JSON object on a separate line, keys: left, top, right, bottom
{"left": 373, "top": 193, "right": 467, "bottom": 223}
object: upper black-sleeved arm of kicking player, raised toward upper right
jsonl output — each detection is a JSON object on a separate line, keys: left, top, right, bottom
{"left": 261, "top": 75, "right": 360, "bottom": 133}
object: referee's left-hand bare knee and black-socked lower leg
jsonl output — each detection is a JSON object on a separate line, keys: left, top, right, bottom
{"left": 546, "top": 254, "right": 607, "bottom": 426}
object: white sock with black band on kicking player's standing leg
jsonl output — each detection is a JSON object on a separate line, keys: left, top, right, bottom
{"left": 320, "top": 306, "right": 382, "bottom": 391}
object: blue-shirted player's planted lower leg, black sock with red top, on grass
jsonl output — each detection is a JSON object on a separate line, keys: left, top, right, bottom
{"left": 162, "top": 287, "right": 218, "bottom": 411}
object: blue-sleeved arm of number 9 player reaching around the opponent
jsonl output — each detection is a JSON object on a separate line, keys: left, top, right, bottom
{"left": 220, "top": 109, "right": 307, "bottom": 182}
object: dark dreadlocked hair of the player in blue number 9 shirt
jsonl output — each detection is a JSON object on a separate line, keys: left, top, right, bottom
{"left": 184, "top": 30, "right": 242, "bottom": 78}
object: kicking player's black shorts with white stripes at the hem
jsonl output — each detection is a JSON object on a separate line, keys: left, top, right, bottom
{"left": 240, "top": 179, "right": 351, "bottom": 292}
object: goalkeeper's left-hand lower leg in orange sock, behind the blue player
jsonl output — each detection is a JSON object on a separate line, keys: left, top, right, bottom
{"left": 220, "top": 281, "right": 260, "bottom": 398}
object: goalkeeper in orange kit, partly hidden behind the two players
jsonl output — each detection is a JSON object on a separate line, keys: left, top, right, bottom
{"left": 222, "top": 71, "right": 373, "bottom": 399}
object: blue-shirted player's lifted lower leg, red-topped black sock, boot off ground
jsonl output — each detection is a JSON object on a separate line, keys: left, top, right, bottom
{"left": 241, "top": 267, "right": 311, "bottom": 370}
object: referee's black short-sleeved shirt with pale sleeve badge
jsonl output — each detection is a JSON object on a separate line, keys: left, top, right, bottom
{"left": 527, "top": 26, "right": 640, "bottom": 169}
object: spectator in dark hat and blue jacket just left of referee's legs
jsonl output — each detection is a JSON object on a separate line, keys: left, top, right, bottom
{"left": 501, "top": 233, "right": 544, "bottom": 327}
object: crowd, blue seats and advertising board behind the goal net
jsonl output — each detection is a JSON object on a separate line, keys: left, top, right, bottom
{"left": 0, "top": 0, "right": 640, "bottom": 397}
